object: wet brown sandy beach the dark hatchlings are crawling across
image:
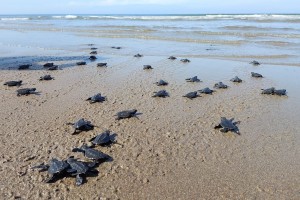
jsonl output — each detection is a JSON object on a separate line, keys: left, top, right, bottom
{"left": 0, "top": 47, "right": 300, "bottom": 199}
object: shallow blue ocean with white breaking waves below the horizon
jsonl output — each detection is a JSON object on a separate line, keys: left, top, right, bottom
{"left": 0, "top": 14, "right": 300, "bottom": 66}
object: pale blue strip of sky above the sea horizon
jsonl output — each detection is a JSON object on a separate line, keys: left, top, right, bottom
{"left": 0, "top": 0, "right": 300, "bottom": 15}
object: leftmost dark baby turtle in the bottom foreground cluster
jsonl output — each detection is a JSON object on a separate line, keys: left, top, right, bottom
{"left": 32, "top": 158, "right": 69, "bottom": 183}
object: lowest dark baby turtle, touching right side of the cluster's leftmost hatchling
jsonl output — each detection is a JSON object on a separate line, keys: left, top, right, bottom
{"left": 67, "top": 157, "right": 98, "bottom": 186}
